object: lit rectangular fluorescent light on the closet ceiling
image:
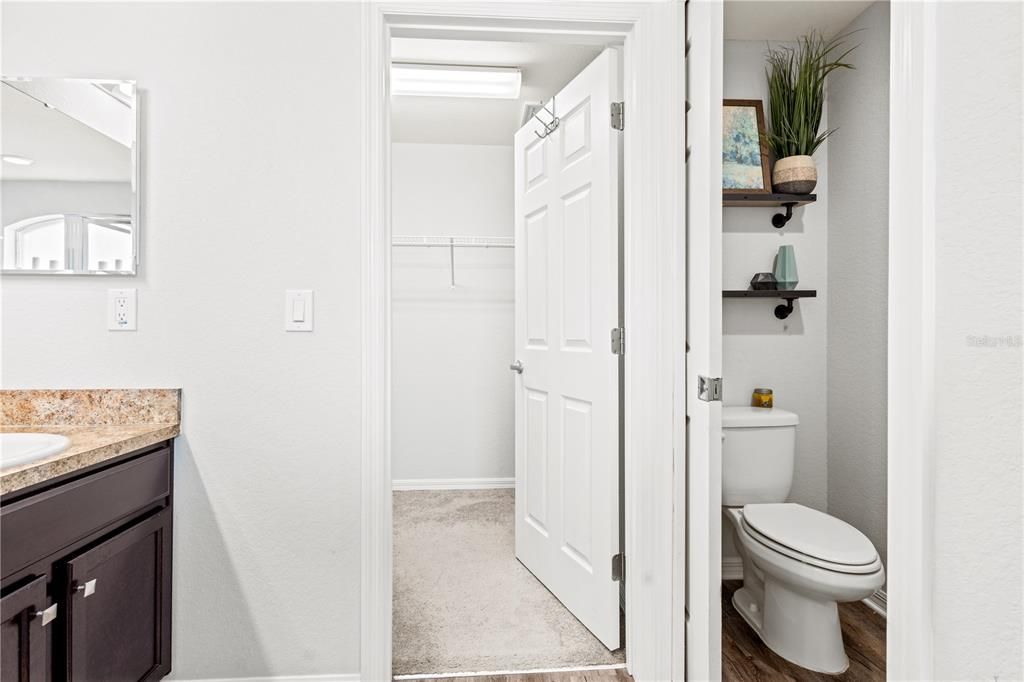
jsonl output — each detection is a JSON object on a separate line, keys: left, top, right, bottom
{"left": 391, "top": 63, "right": 522, "bottom": 99}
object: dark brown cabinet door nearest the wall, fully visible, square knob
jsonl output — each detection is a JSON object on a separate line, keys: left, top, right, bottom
{"left": 67, "top": 509, "right": 171, "bottom": 682}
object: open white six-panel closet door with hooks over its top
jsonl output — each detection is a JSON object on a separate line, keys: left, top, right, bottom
{"left": 515, "top": 49, "right": 623, "bottom": 649}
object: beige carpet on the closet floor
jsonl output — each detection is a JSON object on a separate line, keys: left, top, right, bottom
{"left": 393, "top": 489, "right": 624, "bottom": 675}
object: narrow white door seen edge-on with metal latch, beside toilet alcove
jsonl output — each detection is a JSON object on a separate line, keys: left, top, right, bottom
{"left": 686, "top": 0, "right": 723, "bottom": 680}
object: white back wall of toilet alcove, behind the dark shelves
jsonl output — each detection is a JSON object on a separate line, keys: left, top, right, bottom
{"left": 722, "top": 40, "right": 829, "bottom": 553}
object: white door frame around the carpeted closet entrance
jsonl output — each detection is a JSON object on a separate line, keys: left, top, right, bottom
{"left": 360, "top": 5, "right": 686, "bottom": 682}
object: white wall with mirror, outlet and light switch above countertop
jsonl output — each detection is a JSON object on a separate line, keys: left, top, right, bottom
{"left": 2, "top": 2, "right": 360, "bottom": 679}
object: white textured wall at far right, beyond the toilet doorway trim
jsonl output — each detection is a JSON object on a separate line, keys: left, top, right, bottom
{"left": 933, "top": 2, "right": 1024, "bottom": 680}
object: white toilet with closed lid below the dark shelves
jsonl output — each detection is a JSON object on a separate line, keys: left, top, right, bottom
{"left": 722, "top": 407, "right": 886, "bottom": 674}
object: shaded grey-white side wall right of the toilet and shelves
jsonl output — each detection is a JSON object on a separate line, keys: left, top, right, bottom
{"left": 822, "top": 2, "right": 889, "bottom": 577}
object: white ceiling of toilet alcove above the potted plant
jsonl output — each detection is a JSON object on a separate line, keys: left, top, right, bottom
{"left": 724, "top": 0, "right": 873, "bottom": 40}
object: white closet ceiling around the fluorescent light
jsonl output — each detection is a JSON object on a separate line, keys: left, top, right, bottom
{"left": 391, "top": 38, "right": 602, "bottom": 144}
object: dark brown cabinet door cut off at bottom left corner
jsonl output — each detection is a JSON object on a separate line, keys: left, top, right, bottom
{"left": 0, "top": 576, "right": 51, "bottom": 682}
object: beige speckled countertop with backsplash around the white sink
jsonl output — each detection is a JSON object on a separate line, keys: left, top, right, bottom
{"left": 0, "top": 389, "right": 180, "bottom": 495}
